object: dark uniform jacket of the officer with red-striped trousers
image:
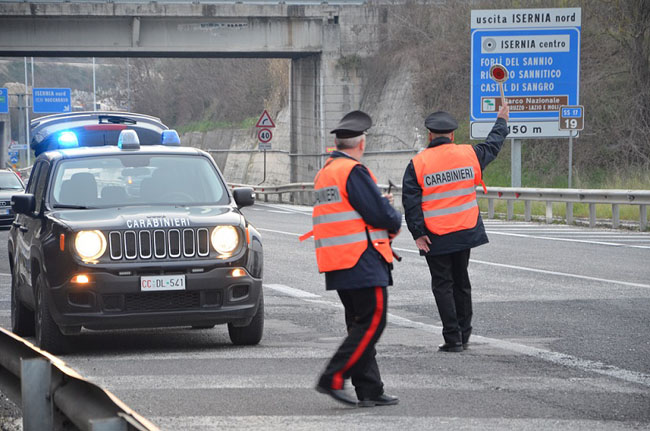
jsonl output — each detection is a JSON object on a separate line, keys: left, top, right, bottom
{"left": 325, "top": 151, "right": 402, "bottom": 290}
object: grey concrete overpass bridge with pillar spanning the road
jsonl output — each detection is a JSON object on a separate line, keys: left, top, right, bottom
{"left": 0, "top": 1, "right": 386, "bottom": 181}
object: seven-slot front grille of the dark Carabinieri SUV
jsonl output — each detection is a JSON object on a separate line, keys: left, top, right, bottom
{"left": 108, "top": 228, "right": 210, "bottom": 260}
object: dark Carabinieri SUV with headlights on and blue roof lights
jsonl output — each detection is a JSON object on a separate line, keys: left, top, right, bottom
{"left": 8, "top": 126, "right": 264, "bottom": 352}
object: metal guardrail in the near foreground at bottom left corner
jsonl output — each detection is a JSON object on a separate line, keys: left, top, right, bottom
{"left": 0, "top": 328, "right": 158, "bottom": 431}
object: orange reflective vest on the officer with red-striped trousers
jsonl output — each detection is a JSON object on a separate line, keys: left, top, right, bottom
{"left": 301, "top": 157, "right": 393, "bottom": 272}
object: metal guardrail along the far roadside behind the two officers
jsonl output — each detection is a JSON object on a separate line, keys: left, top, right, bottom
{"left": 230, "top": 183, "right": 650, "bottom": 231}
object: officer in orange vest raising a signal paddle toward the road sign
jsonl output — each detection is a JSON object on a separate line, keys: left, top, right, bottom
{"left": 402, "top": 104, "right": 509, "bottom": 352}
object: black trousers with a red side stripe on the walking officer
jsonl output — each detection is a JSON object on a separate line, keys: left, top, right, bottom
{"left": 319, "top": 287, "right": 388, "bottom": 399}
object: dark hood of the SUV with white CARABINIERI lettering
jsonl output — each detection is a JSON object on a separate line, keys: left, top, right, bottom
{"left": 49, "top": 205, "right": 243, "bottom": 230}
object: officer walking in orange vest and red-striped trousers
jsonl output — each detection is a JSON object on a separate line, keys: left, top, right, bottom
{"left": 301, "top": 111, "right": 402, "bottom": 407}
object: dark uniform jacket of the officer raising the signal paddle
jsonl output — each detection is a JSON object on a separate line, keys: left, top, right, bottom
{"left": 402, "top": 118, "right": 508, "bottom": 256}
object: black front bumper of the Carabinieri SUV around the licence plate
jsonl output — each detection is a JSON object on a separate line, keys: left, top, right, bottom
{"left": 47, "top": 267, "right": 262, "bottom": 329}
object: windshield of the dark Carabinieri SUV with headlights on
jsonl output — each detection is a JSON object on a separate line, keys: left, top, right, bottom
{"left": 50, "top": 154, "right": 229, "bottom": 208}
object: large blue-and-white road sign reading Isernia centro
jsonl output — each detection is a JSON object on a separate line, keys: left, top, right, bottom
{"left": 470, "top": 8, "right": 581, "bottom": 139}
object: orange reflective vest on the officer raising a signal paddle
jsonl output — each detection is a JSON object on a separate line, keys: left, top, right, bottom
{"left": 413, "top": 143, "right": 483, "bottom": 235}
